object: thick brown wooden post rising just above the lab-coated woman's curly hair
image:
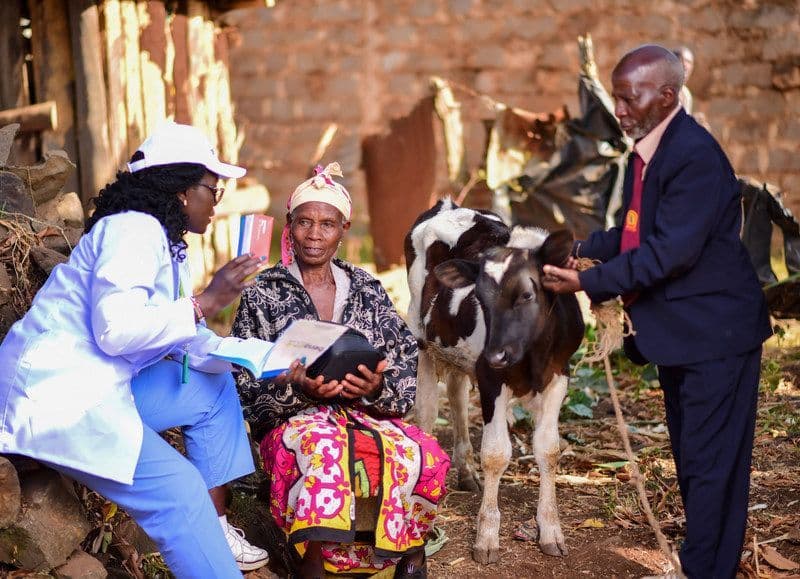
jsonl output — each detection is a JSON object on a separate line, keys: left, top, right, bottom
{"left": 67, "top": 0, "right": 114, "bottom": 203}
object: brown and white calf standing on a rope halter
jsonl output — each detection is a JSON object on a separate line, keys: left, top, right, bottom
{"left": 405, "top": 200, "right": 583, "bottom": 564}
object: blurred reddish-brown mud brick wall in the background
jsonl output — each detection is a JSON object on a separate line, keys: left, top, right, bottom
{"left": 225, "top": 0, "right": 800, "bottom": 247}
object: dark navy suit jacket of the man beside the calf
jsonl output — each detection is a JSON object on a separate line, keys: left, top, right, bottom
{"left": 576, "top": 110, "right": 772, "bottom": 366}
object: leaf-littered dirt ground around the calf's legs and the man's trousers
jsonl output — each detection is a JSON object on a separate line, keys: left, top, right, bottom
{"left": 418, "top": 339, "right": 800, "bottom": 578}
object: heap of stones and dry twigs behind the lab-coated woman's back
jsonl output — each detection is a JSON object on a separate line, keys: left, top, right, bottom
{"left": 0, "top": 124, "right": 84, "bottom": 337}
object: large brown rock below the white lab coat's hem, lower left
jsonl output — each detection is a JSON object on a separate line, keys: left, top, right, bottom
{"left": 0, "top": 469, "right": 91, "bottom": 571}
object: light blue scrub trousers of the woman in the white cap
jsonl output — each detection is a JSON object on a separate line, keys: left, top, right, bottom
{"left": 51, "top": 360, "right": 255, "bottom": 579}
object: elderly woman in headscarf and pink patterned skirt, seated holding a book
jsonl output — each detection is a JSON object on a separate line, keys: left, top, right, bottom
{"left": 233, "top": 163, "right": 450, "bottom": 577}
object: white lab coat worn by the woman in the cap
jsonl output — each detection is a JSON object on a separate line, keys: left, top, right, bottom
{"left": 0, "top": 211, "right": 231, "bottom": 484}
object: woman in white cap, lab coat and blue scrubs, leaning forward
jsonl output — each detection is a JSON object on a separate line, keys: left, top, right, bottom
{"left": 0, "top": 123, "right": 267, "bottom": 577}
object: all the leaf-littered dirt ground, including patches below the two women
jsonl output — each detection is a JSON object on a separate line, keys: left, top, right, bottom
{"left": 15, "top": 322, "right": 800, "bottom": 579}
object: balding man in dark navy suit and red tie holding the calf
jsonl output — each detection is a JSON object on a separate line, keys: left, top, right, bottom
{"left": 544, "top": 45, "right": 771, "bottom": 579}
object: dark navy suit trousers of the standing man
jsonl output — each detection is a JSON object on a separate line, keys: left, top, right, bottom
{"left": 658, "top": 347, "right": 761, "bottom": 579}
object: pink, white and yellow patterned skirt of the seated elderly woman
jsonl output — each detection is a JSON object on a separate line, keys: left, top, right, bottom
{"left": 261, "top": 406, "right": 450, "bottom": 573}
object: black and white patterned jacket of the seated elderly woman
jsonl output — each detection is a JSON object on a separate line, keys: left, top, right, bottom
{"left": 231, "top": 259, "right": 417, "bottom": 439}
